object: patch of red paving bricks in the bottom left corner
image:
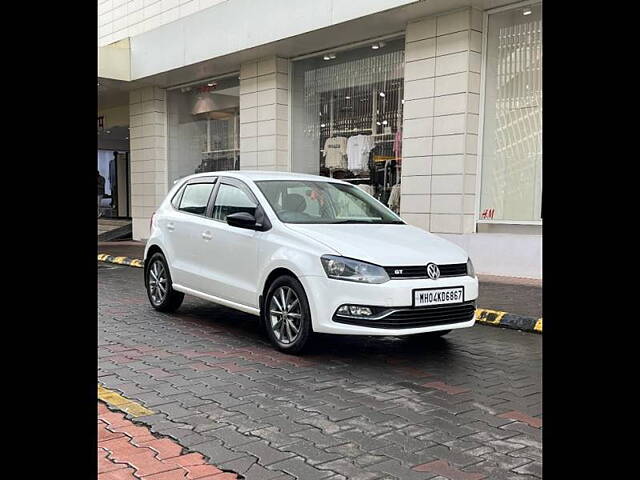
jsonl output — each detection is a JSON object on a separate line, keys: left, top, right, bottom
{"left": 98, "top": 402, "right": 237, "bottom": 480}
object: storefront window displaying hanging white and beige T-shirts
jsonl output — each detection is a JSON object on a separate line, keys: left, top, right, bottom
{"left": 291, "top": 39, "right": 404, "bottom": 211}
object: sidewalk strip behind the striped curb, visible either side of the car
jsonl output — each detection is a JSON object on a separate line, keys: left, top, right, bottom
{"left": 98, "top": 240, "right": 542, "bottom": 318}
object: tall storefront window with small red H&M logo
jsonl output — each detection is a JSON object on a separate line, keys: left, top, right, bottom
{"left": 479, "top": 5, "right": 542, "bottom": 222}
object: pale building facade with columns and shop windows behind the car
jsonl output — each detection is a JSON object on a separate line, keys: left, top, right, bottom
{"left": 98, "top": 0, "right": 542, "bottom": 278}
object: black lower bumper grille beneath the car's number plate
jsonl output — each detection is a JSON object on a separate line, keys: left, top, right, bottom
{"left": 333, "top": 300, "right": 476, "bottom": 328}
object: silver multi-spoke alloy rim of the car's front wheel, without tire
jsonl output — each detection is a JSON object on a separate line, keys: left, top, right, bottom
{"left": 269, "top": 286, "right": 302, "bottom": 345}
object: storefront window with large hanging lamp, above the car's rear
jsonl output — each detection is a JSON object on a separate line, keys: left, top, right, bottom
{"left": 167, "top": 77, "right": 240, "bottom": 185}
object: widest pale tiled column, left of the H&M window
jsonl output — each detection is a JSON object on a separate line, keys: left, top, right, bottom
{"left": 400, "top": 8, "right": 482, "bottom": 234}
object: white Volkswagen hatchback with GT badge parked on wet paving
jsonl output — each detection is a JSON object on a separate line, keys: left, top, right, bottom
{"left": 144, "top": 171, "right": 478, "bottom": 353}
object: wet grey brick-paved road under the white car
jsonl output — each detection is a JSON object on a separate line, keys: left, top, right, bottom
{"left": 98, "top": 264, "right": 542, "bottom": 480}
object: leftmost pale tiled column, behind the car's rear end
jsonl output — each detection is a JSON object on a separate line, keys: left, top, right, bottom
{"left": 129, "top": 87, "right": 167, "bottom": 240}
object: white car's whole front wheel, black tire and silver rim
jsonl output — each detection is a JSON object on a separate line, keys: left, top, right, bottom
{"left": 262, "top": 275, "right": 313, "bottom": 354}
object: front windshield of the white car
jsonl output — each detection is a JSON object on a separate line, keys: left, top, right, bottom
{"left": 256, "top": 180, "right": 404, "bottom": 224}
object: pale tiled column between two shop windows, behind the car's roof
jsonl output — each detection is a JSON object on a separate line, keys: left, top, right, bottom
{"left": 240, "top": 56, "right": 290, "bottom": 171}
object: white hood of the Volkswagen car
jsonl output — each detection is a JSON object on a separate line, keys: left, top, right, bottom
{"left": 287, "top": 223, "right": 468, "bottom": 266}
